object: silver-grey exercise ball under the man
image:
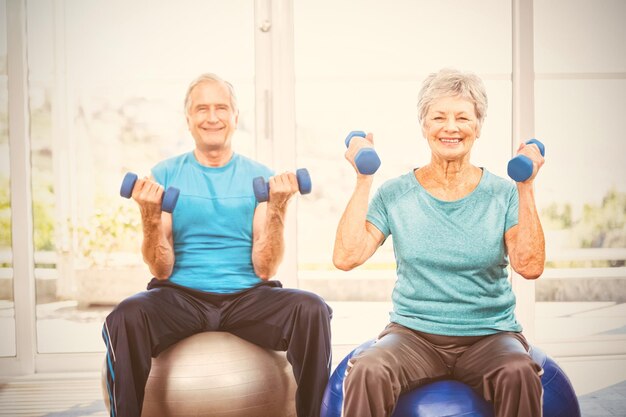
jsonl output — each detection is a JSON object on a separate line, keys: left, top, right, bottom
{"left": 102, "top": 332, "right": 296, "bottom": 417}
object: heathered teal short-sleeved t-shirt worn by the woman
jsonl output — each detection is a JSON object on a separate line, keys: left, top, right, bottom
{"left": 367, "top": 169, "right": 522, "bottom": 336}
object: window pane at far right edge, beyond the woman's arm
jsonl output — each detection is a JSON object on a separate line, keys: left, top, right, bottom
{"left": 534, "top": 0, "right": 626, "bottom": 391}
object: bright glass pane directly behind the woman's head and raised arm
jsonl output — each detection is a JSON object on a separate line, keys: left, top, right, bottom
{"left": 294, "top": 0, "right": 512, "bottom": 292}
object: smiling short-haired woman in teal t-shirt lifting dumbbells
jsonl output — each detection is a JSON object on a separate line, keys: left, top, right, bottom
{"left": 333, "top": 69, "right": 545, "bottom": 417}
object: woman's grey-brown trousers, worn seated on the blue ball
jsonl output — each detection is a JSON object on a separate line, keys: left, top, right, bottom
{"left": 343, "top": 323, "right": 543, "bottom": 417}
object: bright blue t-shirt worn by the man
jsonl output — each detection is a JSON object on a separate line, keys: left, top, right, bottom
{"left": 152, "top": 152, "right": 272, "bottom": 293}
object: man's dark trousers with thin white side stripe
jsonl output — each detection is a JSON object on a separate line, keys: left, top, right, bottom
{"left": 102, "top": 279, "right": 332, "bottom": 417}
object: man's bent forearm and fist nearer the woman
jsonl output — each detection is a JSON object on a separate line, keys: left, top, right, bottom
{"left": 252, "top": 173, "right": 298, "bottom": 280}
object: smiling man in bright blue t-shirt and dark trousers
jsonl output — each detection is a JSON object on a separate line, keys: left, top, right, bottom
{"left": 103, "top": 74, "right": 331, "bottom": 417}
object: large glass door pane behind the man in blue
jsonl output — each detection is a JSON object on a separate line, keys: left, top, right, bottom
{"left": 27, "top": 0, "right": 255, "bottom": 353}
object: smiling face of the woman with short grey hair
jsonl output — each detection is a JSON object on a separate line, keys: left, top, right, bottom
{"left": 422, "top": 96, "right": 480, "bottom": 161}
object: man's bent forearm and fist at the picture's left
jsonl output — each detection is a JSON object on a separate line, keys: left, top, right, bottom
{"left": 132, "top": 178, "right": 174, "bottom": 280}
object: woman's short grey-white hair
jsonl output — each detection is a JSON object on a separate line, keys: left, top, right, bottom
{"left": 417, "top": 68, "right": 487, "bottom": 126}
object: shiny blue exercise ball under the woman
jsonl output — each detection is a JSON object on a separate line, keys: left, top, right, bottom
{"left": 320, "top": 340, "right": 580, "bottom": 417}
